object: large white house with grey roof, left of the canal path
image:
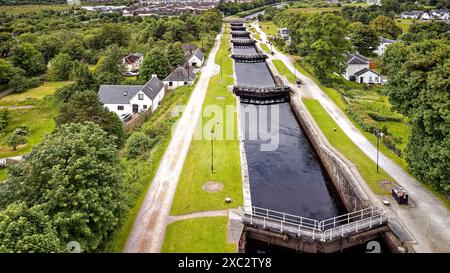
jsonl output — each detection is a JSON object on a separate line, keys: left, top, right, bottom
{"left": 98, "top": 75, "right": 165, "bottom": 116}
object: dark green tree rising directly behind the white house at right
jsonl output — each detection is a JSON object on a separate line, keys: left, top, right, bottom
{"left": 350, "top": 22, "right": 380, "bottom": 55}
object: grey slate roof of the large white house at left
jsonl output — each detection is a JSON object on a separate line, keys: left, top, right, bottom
{"left": 98, "top": 77, "right": 164, "bottom": 104}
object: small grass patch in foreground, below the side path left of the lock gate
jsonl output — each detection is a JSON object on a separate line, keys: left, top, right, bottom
{"left": 162, "top": 217, "right": 236, "bottom": 253}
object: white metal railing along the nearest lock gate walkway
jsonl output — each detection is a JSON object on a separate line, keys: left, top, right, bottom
{"left": 244, "top": 206, "right": 389, "bottom": 242}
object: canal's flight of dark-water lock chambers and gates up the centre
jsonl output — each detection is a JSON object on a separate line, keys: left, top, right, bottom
{"left": 227, "top": 22, "right": 400, "bottom": 252}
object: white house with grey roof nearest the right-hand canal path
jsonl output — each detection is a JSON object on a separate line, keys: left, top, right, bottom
{"left": 344, "top": 53, "right": 381, "bottom": 84}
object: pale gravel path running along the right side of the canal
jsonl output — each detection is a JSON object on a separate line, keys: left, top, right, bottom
{"left": 252, "top": 23, "right": 450, "bottom": 252}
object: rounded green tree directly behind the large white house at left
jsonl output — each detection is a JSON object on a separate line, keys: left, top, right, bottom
{"left": 139, "top": 48, "right": 171, "bottom": 81}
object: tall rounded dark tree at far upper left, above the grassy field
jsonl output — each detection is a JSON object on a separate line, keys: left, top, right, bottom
{"left": 10, "top": 43, "right": 46, "bottom": 76}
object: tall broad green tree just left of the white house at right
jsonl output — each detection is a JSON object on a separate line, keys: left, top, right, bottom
{"left": 300, "top": 13, "right": 350, "bottom": 81}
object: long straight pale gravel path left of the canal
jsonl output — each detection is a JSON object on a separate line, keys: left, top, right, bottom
{"left": 125, "top": 33, "right": 222, "bottom": 253}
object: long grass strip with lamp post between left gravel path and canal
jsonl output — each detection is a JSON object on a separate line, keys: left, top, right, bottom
{"left": 171, "top": 28, "right": 242, "bottom": 215}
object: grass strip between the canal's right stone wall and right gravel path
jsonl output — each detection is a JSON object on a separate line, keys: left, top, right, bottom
{"left": 303, "top": 99, "right": 394, "bottom": 194}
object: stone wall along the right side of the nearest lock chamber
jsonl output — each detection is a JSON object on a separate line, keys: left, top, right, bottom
{"left": 290, "top": 94, "right": 373, "bottom": 212}
